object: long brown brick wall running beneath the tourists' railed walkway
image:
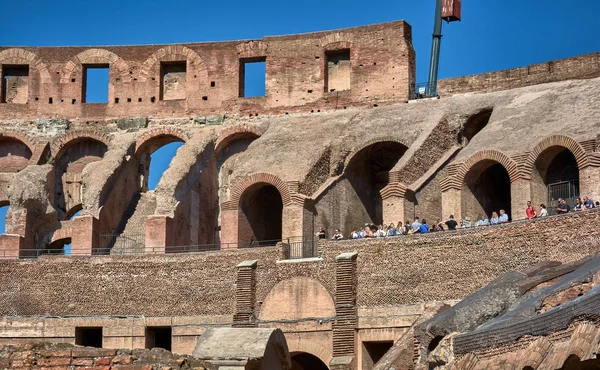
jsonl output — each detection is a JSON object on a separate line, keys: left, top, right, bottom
{"left": 0, "top": 210, "right": 600, "bottom": 316}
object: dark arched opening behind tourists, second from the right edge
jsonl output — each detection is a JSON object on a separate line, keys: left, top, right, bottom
{"left": 462, "top": 159, "right": 512, "bottom": 224}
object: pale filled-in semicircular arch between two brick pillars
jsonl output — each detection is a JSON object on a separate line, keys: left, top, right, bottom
{"left": 259, "top": 277, "right": 335, "bottom": 321}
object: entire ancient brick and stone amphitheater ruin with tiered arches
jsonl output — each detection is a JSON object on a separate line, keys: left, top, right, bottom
{"left": 0, "top": 21, "right": 600, "bottom": 370}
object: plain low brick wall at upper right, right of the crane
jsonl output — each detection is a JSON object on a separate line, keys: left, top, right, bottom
{"left": 438, "top": 53, "right": 600, "bottom": 97}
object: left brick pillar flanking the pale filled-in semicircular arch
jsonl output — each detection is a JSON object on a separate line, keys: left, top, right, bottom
{"left": 233, "top": 261, "right": 258, "bottom": 328}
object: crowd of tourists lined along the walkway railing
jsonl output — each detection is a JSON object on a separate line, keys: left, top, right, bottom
{"left": 316, "top": 196, "right": 600, "bottom": 240}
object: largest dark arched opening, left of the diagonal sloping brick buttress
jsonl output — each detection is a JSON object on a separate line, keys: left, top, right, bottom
{"left": 336, "top": 141, "right": 407, "bottom": 228}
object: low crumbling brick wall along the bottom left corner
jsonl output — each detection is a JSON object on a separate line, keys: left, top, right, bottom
{"left": 0, "top": 343, "right": 204, "bottom": 370}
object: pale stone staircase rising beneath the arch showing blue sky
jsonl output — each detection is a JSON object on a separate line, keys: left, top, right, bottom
{"left": 110, "top": 191, "right": 156, "bottom": 254}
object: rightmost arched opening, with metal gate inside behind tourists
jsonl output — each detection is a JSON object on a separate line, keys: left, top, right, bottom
{"left": 532, "top": 146, "right": 580, "bottom": 213}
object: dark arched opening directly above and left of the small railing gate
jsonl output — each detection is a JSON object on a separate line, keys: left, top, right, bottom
{"left": 238, "top": 183, "right": 283, "bottom": 247}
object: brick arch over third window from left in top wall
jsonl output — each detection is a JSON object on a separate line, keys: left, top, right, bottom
{"left": 139, "top": 45, "right": 208, "bottom": 82}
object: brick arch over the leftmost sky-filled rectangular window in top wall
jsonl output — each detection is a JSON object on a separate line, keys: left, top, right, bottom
{"left": 60, "top": 48, "right": 129, "bottom": 83}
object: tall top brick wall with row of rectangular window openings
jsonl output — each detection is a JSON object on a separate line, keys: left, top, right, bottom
{"left": 0, "top": 21, "right": 415, "bottom": 119}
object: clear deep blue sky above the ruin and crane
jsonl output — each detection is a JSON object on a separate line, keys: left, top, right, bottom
{"left": 0, "top": 0, "right": 600, "bottom": 238}
